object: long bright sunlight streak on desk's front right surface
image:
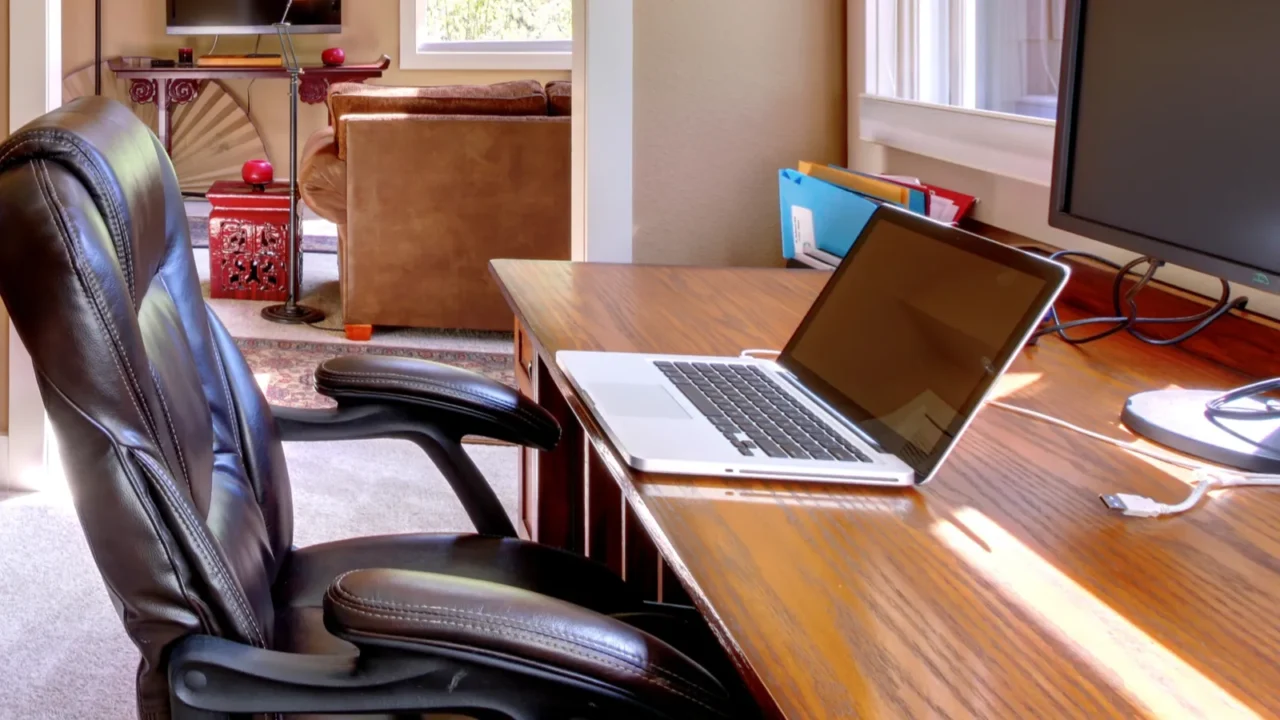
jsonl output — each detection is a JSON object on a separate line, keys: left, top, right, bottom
{"left": 933, "top": 507, "right": 1258, "bottom": 720}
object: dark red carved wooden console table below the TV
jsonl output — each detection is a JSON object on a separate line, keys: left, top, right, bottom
{"left": 109, "top": 55, "right": 392, "bottom": 150}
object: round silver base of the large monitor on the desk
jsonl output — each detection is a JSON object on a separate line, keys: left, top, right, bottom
{"left": 1120, "top": 389, "right": 1280, "bottom": 474}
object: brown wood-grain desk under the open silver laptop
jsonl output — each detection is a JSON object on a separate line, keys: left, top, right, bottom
{"left": 493, "top": 260, "right": 1280, "bottom": 720}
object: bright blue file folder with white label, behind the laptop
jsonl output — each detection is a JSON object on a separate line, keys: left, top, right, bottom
{"left": 778, "top": 170, "right": 877, "bottom": 260}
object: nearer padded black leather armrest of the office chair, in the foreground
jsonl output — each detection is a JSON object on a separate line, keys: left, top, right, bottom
{"left": 324, "top": 569, "right": 736, "bottom": 719}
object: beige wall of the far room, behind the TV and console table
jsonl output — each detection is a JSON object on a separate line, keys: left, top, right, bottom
{"left": 63, "top": 0, "right": 570, "bottom": 170}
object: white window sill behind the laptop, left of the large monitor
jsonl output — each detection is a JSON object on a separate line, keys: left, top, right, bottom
{"left": 859, "top": 95, "right": 1055, "bottom": 187}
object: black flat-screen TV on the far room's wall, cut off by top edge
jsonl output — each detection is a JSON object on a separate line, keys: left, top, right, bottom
{"left": 166, "top": 0, "right": 342, "bottom": 35}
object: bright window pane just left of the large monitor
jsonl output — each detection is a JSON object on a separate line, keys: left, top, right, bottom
{"left": 867, "top": 0, "right": 1065, "bottom": 119}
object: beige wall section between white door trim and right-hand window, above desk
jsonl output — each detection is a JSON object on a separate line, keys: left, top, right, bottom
{"left": 632, "top": 0, "right": 847, "bottom": 265}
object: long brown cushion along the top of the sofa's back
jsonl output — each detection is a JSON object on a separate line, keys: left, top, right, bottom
{"left": 329, "top": 79, "right": 547, "bottom": 160}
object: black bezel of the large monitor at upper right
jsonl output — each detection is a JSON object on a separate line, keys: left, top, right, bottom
{"left": 1048, "top": 0, "right": 1280, "bottom": 293}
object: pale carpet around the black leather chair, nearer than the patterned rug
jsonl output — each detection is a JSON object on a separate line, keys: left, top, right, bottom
{"left": 0, "top": 441, "right": 517, "bottom": 720}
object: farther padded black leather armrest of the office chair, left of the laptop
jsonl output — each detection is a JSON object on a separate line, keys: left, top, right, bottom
{"left": 315, "top": 355, "right": 561, "bottom": 450}
